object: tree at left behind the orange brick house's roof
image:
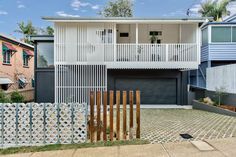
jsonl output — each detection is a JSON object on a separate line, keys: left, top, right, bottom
{"left": 15, "top": 21, "right": 37, "bottom": 44}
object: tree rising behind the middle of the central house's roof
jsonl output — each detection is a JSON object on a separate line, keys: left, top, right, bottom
{"left": 99, "top": 0, "right": 133, "bottom": 17}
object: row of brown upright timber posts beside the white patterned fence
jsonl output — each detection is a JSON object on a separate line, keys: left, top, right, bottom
{"left": 89, "top": 90, "right": 141, "bottom": 142}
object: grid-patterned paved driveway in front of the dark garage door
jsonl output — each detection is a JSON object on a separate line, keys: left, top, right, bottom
{"left": 141, "top": 109, "right": 236, "bottom": 143}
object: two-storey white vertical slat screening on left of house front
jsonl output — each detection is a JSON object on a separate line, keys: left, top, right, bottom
{"left": 54, "top": 23, "right": 109, "bottom": 103}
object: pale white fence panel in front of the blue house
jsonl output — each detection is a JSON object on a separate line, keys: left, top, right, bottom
{"left": 206, "top": 64, "right": 236, "bottom": 93}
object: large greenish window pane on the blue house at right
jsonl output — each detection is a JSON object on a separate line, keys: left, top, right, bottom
{"left": 211, "top": 26, "right": 231, "bottom": 42}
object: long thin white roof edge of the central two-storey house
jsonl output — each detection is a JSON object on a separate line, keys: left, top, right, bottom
{"left": 42, "top": 16, "right": 209, "bottom": 23}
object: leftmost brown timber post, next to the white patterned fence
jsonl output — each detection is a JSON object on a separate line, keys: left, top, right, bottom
{"left": 89, "top": 91, "right": 94, "bottom": 142}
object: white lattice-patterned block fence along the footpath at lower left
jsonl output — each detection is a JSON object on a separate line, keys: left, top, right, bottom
{"left": 0, "top": 103, "right": 87, "bottom": 147}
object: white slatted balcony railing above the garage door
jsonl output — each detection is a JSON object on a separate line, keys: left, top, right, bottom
{"left": 104, "top": 44, "right": 198, "bottom": 62}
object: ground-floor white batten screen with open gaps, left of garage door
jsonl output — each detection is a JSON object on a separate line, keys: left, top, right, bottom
{"left": 55, "top": 65, "right": 107, "bottom": 103}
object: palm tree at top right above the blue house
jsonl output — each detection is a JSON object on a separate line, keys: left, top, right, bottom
{"left": 199, "top": 0, "right": 230, "bottom": 21}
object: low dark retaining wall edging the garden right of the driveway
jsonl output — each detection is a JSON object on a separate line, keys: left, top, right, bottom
{"left": 193, "top": 100, "right": 236, "bottom": 117}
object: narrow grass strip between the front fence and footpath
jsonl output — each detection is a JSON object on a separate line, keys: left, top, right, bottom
{"left": 0, "top": 140, "right": 149, "bottom": 155}
